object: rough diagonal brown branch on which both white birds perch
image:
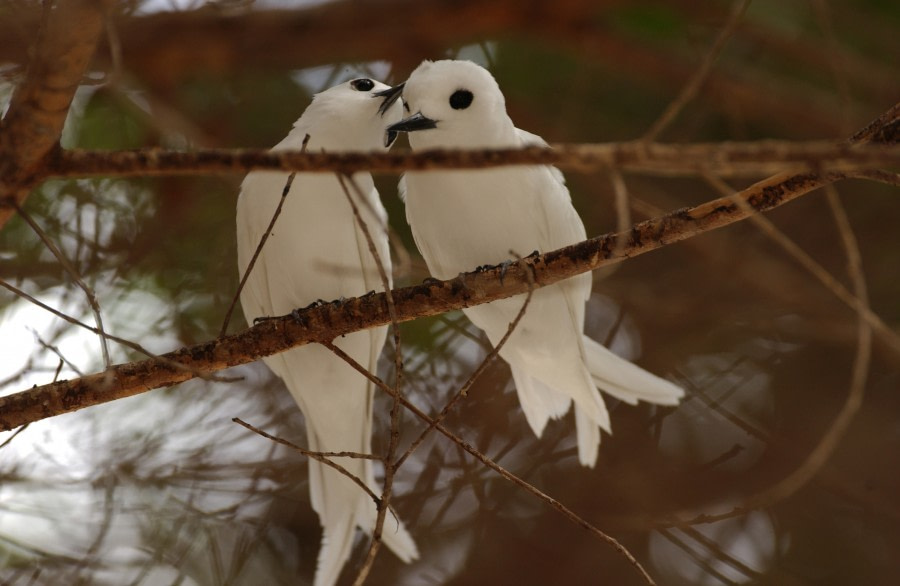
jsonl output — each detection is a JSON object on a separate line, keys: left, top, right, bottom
{"left": 0, "top": 167, "right": 838, "bottom": 431}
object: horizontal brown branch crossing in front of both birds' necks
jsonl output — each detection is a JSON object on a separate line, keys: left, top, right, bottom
{"left": 47, "top": 140, "right": 900, "bottom": 177}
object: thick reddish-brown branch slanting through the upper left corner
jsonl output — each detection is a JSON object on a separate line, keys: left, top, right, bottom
{"left": 0, "top": 0, "right": 105, "bottom": 227}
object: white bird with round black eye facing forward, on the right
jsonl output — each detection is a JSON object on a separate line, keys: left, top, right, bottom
{"left": 383, "top": 60, "right": 684, "bottom": 466}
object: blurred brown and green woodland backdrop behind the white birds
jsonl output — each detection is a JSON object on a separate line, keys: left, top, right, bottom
{"left": 0, "top": 0, "right": 900, "bottom": 585}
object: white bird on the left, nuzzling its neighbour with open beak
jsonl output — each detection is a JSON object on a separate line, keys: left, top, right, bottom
{"left": 237, "top": 78, "right": 418, "bottom": 586}
